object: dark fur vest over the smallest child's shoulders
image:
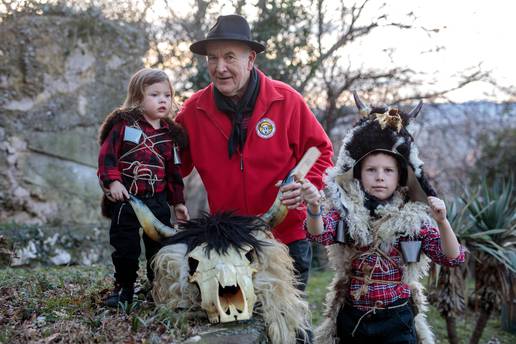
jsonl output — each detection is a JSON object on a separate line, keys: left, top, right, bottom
{"left": 98, "top": 109, "right": 188, "bottom": 218}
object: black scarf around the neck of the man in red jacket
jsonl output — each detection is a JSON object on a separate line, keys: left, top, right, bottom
{"left": 214, "top": 68, "right": 260, "bottom": 159}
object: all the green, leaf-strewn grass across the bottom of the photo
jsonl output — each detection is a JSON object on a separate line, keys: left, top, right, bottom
{"left": 0, "top": 266, "right": 516, "bottom": 344}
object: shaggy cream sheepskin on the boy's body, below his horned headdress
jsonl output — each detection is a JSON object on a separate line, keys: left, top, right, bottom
{"left": 315, "top": 179, "right": 435, "bottom": 344}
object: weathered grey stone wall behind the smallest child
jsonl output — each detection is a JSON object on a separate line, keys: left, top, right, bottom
{"left": 0, "top": 14, "right": 149, "bottom": 225}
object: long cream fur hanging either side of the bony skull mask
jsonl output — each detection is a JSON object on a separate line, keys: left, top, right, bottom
{"left": 152, "top": 232, "right": 310, "bottom": 344}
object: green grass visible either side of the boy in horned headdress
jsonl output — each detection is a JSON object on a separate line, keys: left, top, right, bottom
{"left": 307, "top": 270, "right": 516, "bottom": 344}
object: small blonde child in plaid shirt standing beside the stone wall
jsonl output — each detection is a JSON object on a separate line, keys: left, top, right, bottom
{"left": 97, "top": 68, "right": 189, "bottom": 307}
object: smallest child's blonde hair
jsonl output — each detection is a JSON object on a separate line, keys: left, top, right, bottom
{"left": 122, "top": 68, "right": 179, "bottom": 117}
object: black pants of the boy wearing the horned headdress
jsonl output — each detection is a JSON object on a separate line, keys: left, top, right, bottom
{"left": 337, "top": 301, "right": 417, "bottom": 344}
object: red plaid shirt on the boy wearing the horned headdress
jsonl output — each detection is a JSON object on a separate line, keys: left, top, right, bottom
{"left": 305, "top": 210, "right": 464, "bottom": 310}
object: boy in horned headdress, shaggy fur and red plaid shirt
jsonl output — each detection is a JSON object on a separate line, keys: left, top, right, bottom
{"left": 303, "top": 93, "right": 464, "bottom": 343}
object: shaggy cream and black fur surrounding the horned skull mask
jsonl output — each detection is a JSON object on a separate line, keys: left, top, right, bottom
{"left": 147, "top": 214, "right": 310, "bottom": 344}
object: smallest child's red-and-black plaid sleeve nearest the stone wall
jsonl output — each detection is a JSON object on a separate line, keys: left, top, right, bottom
{"left": 97, "top": 123, "right": 124, "bottom": 188}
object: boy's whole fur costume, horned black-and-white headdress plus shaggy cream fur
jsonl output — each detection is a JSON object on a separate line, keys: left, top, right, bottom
{"left": 315, "top": 93, "right": 435, "bottom": 344}
